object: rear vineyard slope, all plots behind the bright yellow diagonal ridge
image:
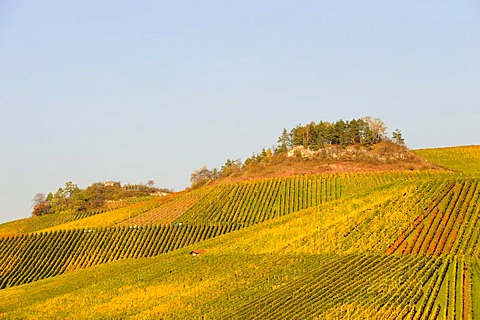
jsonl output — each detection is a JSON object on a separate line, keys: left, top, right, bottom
{"left": 0, "top": 175, "right": 352, "bottom": 289}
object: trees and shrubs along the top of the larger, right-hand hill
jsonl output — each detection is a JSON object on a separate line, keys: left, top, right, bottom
{"left": 190, "top": 117, "right": 405, "bottom": 188}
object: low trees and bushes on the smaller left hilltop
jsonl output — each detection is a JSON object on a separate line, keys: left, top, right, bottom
{"left": 32, "top": 180, "right": 171, "bottom": 216}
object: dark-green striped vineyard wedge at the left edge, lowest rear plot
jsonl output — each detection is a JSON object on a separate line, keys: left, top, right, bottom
{"left": 0, "top": 225, "right": 244, "bottom": 289}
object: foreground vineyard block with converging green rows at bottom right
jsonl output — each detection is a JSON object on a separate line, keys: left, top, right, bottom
{"left": 222, "top": 255, "right": 478, "bottom": 319}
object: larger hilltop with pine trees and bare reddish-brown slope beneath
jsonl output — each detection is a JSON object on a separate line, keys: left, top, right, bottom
{"left": 191, "top": 117, "right": 441, "bottom": 188}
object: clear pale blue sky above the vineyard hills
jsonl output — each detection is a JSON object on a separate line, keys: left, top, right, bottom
{"left": 0, "top": 0, "right": 480, "bottom": 223}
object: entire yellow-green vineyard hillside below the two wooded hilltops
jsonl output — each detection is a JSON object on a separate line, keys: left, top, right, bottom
{"left": 0, "top": 147, "right": 480, "bottom": 319}
